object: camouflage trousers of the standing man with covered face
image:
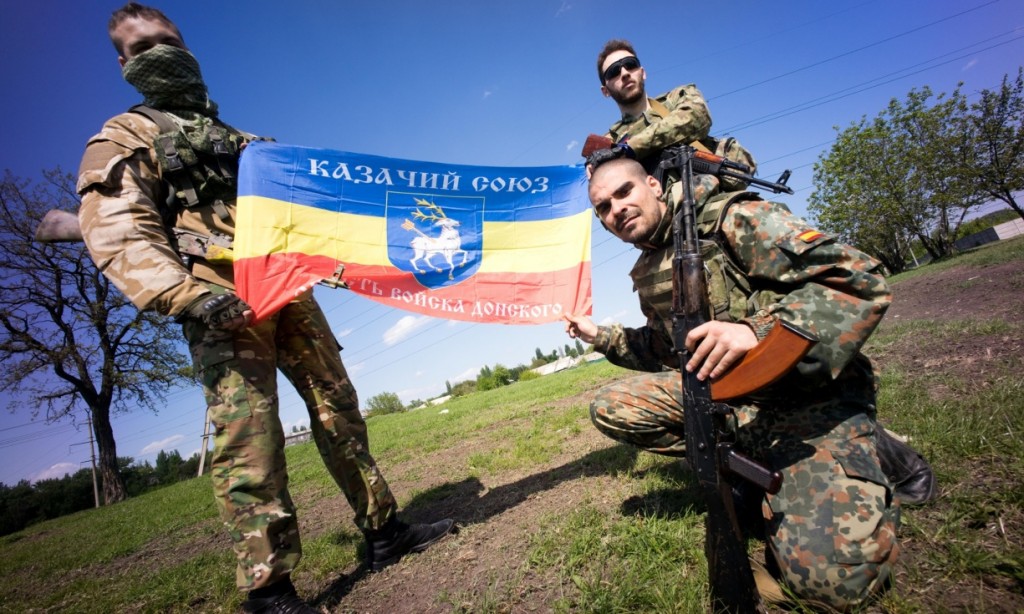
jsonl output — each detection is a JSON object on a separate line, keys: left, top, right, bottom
{"left": 183, "top": 287, "right": 396, "bottom": 590}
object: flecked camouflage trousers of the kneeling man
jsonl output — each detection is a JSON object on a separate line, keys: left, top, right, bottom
{"left": 591, "top": 371, "right": 899, "bottom": 610}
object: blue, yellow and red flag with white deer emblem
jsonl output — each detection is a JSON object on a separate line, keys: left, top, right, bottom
{"left": 234, "top": 141, "right": 593, "bottom": 324}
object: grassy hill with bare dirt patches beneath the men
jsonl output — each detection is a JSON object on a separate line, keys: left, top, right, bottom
{"left": 0, "top": 239, "right": 1024, "bottom": 613}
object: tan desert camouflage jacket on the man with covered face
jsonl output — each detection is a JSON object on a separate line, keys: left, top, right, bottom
{"left": 77, "top": 113, "right": 248, "bottom": 315}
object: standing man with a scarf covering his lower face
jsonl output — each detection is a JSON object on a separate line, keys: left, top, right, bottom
{"left": 78, "top": 3, "right": 454, "bottom": 612}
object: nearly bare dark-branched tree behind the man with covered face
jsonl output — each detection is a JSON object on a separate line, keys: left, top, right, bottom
{"left": 0, "top": 169, "right": 191, "bottom": 503}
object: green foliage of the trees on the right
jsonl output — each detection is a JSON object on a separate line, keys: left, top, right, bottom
{"left": 808, "top": 73, "right": 1024, "bottom": 273}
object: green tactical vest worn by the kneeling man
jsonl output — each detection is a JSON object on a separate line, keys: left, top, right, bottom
{"left": 630, "top": 192, "right": 782, "bottom": 331}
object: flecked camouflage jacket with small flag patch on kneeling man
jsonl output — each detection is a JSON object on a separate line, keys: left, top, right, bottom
{"left": 594, "top": 189, "right": 892, "bottom": 386}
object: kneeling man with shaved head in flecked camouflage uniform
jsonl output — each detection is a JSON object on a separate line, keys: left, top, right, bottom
{"left": 565, "top": 158, "right": 900, "bottom": 610}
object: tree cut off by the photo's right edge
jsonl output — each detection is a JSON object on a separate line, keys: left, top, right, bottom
{"left": 968, "top": 68, "right": 1024, "bottom": 218}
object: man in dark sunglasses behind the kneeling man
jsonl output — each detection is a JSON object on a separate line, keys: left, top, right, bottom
{"left": 597, "top": 39, "right": 757, "bottom": 191}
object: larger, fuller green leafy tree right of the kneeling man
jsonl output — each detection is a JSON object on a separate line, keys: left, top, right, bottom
{"left": 808, "top": 87, "right": 980, "bottom": 272}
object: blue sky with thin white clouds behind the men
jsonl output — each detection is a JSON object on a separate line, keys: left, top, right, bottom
{"left": 0, "top": 0, "right": 1024, "bottom": 484}
